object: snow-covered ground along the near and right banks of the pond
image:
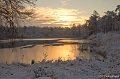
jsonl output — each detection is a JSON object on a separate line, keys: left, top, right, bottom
{"left": 0, "top": 33, "right": 120, "bottom": 79}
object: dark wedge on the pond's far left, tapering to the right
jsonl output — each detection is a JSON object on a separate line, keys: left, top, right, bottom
{"left": 0, "top": 40, "right": 58, "bottom": 49}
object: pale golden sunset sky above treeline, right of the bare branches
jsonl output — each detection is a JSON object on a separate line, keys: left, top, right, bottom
{"left": 28, "top": 0, "right": 120, "bottom": 27}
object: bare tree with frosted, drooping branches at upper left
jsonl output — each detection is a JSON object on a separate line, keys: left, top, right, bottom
{"left": 0, "top": 0, "right": 36, "bottom": 39}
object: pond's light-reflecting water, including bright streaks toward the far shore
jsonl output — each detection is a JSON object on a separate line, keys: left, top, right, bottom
{"left": 0, "top": 38, "right": 90, "bottom": 64}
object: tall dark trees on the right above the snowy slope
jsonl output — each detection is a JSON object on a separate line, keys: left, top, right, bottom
{"left": 79, "top": 5, "right": 120, "bottom": 34}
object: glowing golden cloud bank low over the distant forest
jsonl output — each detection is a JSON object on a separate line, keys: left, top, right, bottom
{"left": 24, "top": 7, "right": 87, "bottom": 26}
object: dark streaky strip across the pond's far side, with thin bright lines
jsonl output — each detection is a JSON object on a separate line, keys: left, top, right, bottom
{"left": 0, "top": 38, "right": 90, "bottom": 49}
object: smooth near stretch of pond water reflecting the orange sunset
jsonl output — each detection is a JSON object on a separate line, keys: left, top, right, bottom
{"left": 0, "top": 40, "right": 90, "bottom": 64}
